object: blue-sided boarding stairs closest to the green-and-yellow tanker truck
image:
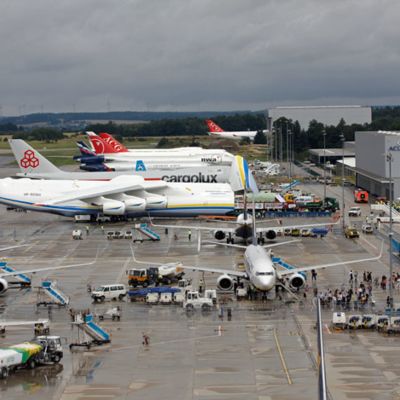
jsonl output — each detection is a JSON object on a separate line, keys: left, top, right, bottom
{"left": 70, "top": 312, "right": 111, "bottom": 348}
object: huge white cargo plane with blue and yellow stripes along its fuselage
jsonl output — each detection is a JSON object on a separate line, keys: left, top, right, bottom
{"left": 0, "top": 175, "right": 234, "bottom": 217}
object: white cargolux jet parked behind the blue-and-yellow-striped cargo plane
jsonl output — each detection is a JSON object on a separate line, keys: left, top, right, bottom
{"left": 9, "top": 139, "right": 234, "bottom": 183}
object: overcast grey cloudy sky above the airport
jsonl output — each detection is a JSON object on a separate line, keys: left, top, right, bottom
{"left": 0, "top": 0, "right": 400, "bottom": 115}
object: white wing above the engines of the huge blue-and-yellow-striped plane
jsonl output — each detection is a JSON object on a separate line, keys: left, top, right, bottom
{"left": 37, "top": 175, "right": 166, "bottom": 204}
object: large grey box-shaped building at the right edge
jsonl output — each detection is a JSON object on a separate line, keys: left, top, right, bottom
{"left": 355, "top": 131, "right": 400, "bottom": 200}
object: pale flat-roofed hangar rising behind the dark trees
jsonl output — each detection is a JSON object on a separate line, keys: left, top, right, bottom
{"left": 268, "top": 106, "right": 372, "bottom": 129}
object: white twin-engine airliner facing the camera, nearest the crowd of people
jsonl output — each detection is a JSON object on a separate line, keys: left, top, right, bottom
{"left": 134, "top": 240, "right": 383, "bottom": 292}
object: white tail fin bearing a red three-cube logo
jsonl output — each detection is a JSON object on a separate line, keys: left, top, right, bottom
{"left": 8, "top": 139, "right": 61, "bottom": 173}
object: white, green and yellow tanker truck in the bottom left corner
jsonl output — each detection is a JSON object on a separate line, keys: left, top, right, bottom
{"left": 0, "top": 336, "right": 63, "bottom": 379}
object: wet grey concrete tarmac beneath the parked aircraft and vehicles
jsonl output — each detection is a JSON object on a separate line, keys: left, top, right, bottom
{"left": 0, "top": 177, "right": 400, "bottom": 400}
